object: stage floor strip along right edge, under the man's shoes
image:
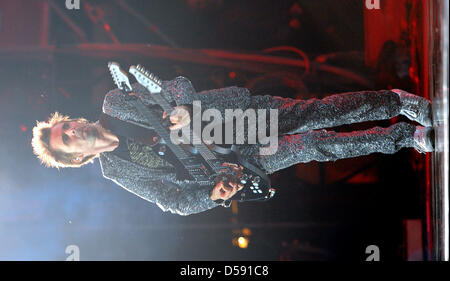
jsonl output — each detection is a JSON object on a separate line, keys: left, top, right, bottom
{"left": 426, "top": 1, "right": 449, "bottom": 261}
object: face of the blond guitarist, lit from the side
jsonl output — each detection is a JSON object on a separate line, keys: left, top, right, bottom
{"left": 50, "top": 121, "right": 99, "bottom": 156}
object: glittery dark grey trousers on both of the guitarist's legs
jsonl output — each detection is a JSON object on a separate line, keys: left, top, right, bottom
{"left": 244, "top": 90, "right": 416, "bottom": 174}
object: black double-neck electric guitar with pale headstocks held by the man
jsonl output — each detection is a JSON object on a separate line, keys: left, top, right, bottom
{"left": 108, "top": 62, "right": 275, "bottom": 203}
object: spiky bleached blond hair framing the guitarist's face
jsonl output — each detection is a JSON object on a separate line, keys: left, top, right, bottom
{"left": 31, "top": 112, "right": 99, "bottom": 169}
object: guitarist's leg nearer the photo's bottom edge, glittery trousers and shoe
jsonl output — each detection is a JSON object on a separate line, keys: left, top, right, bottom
{"left": 254, "top": 122, "right": 431, "bottom": 174}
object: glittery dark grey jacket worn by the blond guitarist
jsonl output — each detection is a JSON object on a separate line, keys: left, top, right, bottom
{"left": 100, "top": 76, "right": 250, "bottom": 216}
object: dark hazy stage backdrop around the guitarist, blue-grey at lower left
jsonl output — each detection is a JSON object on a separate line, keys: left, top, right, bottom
{"left": 0, "top": 0, "right": 424, "bottom": 260}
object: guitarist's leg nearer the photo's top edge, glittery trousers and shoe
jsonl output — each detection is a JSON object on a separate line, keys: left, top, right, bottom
{"left": 250, "top": 90, "right": 431, "bottom": 135}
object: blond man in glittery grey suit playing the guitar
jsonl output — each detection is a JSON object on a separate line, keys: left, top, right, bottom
{"left": 32, "top": 74, "right": 434, "bottom": 215}
